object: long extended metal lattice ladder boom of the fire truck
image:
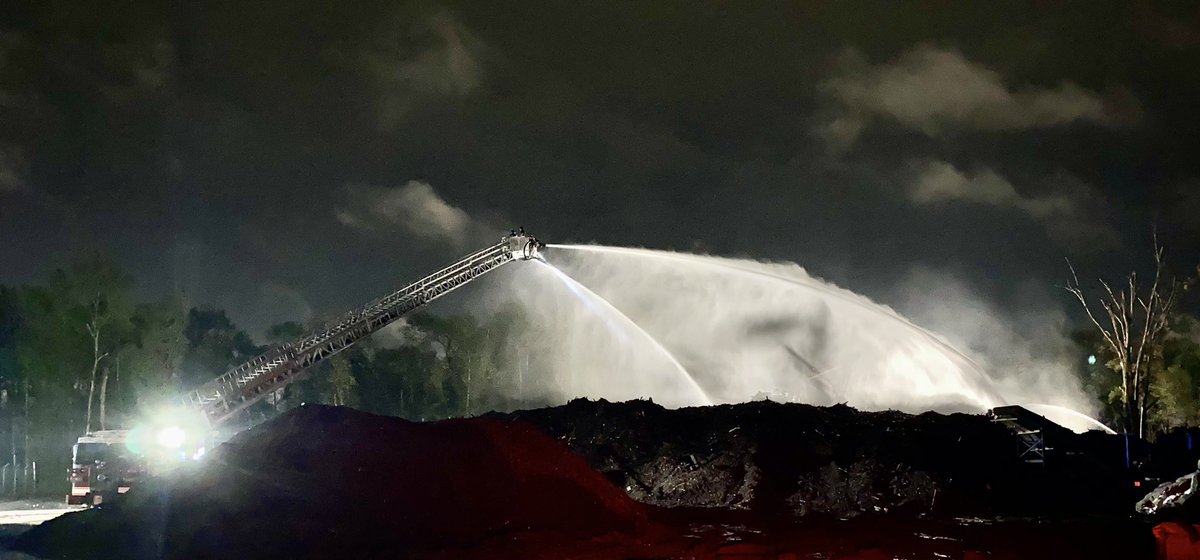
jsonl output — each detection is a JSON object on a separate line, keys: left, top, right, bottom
{"left": 182, "top": 229, "right": 540, "bottom": 427}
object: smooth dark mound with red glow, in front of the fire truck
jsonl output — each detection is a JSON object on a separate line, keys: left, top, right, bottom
{"left": 17, "top": 407, "right": 644, "bottom": 559}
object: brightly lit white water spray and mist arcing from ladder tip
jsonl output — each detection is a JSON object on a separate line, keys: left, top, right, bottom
{"left": 475, "top": 245, "right": 1100, "bottom": 430}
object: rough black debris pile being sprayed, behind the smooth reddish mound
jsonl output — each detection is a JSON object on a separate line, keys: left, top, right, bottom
{"left": 503, "top": 399, "right": 1132, "bottom": 518}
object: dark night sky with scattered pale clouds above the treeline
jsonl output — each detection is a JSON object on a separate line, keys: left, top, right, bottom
{"left": 0, "top": 0, "right": 1200, "bottom": 335}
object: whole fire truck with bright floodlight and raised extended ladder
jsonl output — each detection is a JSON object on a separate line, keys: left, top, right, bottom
{"left": 60, "top": 228, "right": 542, "bottom": 506}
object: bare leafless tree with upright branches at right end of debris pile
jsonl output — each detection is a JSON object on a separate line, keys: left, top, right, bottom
{"left": 1066, "top": 241, "right": 1180, "bottom": 438}
